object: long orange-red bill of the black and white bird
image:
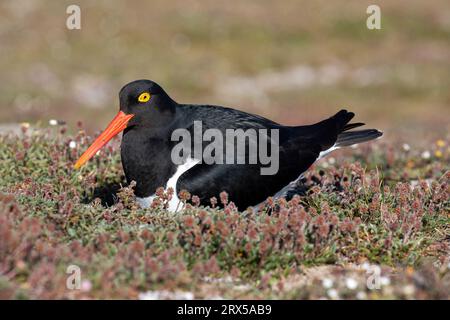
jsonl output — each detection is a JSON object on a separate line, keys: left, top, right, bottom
{"left": 74, "top": 111, "right": 134, "bottom": 169}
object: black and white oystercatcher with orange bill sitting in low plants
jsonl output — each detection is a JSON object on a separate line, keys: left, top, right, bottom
{"left": 75, "top": 80, "right": 382, "bottom": 211}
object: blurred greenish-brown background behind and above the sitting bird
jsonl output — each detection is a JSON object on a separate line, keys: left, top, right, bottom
{"left": 0, "top": 0, "right": 450, "bottom": 139}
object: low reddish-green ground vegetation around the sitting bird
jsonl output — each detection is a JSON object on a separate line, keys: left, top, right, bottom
{"left": 0, "top": 126, "right": 450, "bottom": 299}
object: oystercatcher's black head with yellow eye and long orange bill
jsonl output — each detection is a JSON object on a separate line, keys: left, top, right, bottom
{"left": 75, "top": 80, "right": 176, "bottom": 169}
